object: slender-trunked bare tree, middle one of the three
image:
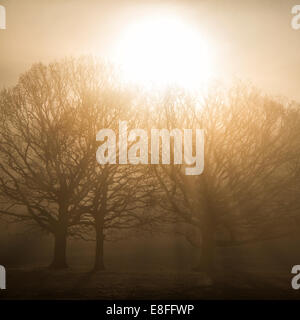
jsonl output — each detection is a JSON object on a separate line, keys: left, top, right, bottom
{"left": 72, "top": 94, "right": 160, "bottom": 270}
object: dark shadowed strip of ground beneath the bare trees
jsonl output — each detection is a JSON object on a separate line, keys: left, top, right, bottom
{"left": 0, "top": 268, "right": 300, "bottom": 300}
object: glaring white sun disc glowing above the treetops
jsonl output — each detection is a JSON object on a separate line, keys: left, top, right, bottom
{"left": 115, "top": 16, "right": 212, "bottom": 89}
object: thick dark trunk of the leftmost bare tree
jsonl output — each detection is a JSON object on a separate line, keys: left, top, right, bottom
{"left": 50, "top": 228, "right": 68, "bottom": 269}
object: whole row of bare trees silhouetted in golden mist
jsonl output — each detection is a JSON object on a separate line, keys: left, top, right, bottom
{"left": 0, "top": 57, "right": 300, "bottom": 273}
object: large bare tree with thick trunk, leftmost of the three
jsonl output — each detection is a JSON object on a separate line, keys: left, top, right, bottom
{"left": 0, "top": 58, "right": 122, "bottom": 268}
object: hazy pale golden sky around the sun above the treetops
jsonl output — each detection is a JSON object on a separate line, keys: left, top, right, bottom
{"left": 0, "top": 0, "right": 300, "bottom": 101}
